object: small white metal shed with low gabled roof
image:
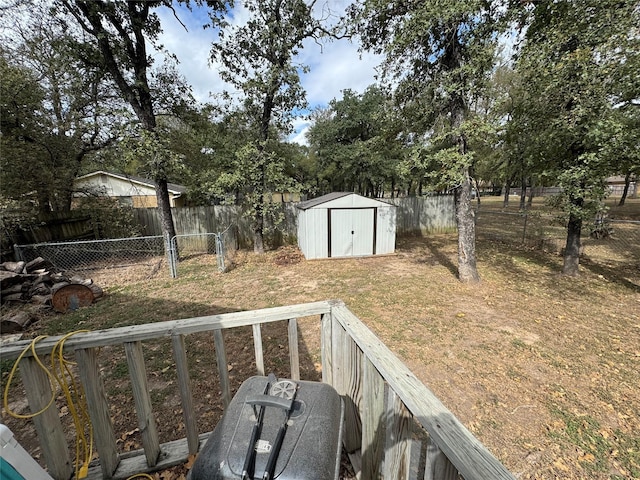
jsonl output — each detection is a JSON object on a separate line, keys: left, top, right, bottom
{"left": 297, "top": 192, "right": 396, "bottom": 259}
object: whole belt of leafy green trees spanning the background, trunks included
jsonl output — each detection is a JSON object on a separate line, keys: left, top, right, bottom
{"left": 0, "top": 0, "right": 640, "bottom": 274}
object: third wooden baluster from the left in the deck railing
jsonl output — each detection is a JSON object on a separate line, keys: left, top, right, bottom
{"left": 124, "top": 342, "right": 160, "bottom": 467}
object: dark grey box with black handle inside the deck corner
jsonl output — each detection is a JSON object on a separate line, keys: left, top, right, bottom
{"left": 187, "top": 375, "right": 344, "bottom": 480}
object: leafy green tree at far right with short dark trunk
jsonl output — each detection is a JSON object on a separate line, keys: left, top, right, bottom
{"left": 511, "top": 0, "right": 640, "bottom": 275}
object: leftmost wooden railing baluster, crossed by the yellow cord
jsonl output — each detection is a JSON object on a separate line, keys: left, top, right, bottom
{"left": 20, "top": 357, "right": 73, "bottom": 478}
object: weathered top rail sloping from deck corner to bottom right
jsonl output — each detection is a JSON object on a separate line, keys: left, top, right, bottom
{"left": 332, "top": 304, "right": 514, "bottom": 480}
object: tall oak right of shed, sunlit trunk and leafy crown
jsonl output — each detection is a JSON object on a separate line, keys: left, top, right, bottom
{"left": 350, "top": 0, "right": 499, "bottom": 283}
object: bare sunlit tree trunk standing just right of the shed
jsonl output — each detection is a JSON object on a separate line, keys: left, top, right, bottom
{"left": 454, "top": 169, "right": 480, "bottom": 283}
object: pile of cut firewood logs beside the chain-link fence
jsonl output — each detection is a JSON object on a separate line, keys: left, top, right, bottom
{"left": 0, "top": 257, "right": 104, "bottom": 333}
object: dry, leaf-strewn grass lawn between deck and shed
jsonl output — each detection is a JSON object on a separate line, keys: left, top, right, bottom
{"left": 3, "top": 211, "right": 640, "bottom": 479}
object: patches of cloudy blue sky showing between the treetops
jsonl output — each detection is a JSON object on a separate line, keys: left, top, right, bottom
{"left": 158, "top": 0, "right": 380, "bottom": 143}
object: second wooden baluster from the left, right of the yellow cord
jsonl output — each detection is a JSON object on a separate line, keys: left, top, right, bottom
{"left": 75, "top": 348, "right": 120, "bottom": 478}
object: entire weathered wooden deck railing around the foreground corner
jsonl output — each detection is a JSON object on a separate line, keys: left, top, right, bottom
{"left": 0, "top": 301, "right": 514, "bottom": 480}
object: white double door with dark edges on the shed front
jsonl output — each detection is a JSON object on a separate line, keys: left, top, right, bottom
{"left": 330, "top": 208, "right": 375, "bottom": 257}
